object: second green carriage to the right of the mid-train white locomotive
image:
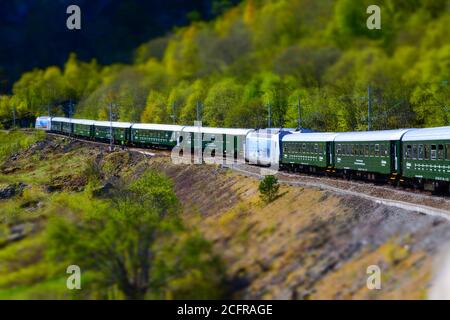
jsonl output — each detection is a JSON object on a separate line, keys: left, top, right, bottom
{"left": 334, "top": 129, "right": 409, "bottom": 180}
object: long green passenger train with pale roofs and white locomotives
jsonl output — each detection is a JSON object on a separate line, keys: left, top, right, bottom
{"left": 36, "top": 116, "right": 450, "bottom": 193}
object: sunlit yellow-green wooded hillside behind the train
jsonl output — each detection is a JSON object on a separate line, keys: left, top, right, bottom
{"left": 0, "top": 0, "right": 450, "bottom": 131}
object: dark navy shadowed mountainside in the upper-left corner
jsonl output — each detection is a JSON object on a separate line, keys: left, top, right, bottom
{"left": 0, "top": 0, "right": 238, "bottom": 94}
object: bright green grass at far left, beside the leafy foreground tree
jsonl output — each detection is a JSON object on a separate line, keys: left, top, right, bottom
{"left": 0, "top": 130, "right": 89, "bottom": 299}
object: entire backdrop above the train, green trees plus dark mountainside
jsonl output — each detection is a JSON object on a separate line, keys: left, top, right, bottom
{"left": 0, "top": 0, "right": 450, "bottom": 131}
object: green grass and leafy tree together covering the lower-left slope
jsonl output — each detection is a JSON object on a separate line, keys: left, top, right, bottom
{"left": 0, "top": 131, "right": 227, "bottom": 299}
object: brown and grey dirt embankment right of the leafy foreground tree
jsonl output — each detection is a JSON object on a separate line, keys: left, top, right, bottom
{"left": 150, "top": 159, "right": 450, "bottom": 299}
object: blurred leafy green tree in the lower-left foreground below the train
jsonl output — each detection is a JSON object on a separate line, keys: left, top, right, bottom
{"left": 46, "top": 171, "right": 223, "bottom": 299}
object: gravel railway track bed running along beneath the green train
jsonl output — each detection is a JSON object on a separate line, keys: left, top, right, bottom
{"left": 47, "top": 133, "right": 450, "bottom": 221}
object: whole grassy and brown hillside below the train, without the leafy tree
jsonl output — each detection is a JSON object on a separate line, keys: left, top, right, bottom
{"left": 0, "top": 129, "right": 450, "bottom": 299}
